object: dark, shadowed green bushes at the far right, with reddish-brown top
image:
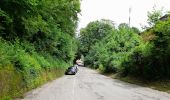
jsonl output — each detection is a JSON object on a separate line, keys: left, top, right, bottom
{"left": 124, "top": 15, "right": 170, "bottom": 80}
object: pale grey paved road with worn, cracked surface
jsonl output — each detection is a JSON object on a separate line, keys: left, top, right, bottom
{"left": 19, "top": 67, "right": 170, "bottom": 100}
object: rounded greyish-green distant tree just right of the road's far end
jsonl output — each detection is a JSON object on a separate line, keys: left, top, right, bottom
{"left": 80, "top": 20, "right": 114, "bottom": 55}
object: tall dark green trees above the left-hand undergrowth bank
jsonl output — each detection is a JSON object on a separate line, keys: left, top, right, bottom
{"left": 0, "top": 0, "right": 80, "bottom": 62}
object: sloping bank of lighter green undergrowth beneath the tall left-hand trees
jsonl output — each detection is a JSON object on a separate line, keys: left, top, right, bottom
{"left": 0, "top": 38, "right": 68, "bottom": 100}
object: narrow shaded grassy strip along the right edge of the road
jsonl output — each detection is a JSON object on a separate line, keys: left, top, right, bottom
{"left": 104, "top": 73, "right": 170, "bottom": 93}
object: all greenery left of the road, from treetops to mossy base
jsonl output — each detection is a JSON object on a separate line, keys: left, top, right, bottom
{"left": 0, "top": 0, "right": 80, "bottom": 100}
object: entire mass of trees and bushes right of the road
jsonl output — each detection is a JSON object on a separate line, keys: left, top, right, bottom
{"left": 80, "top": 9, "right": 170, "bottom": 81}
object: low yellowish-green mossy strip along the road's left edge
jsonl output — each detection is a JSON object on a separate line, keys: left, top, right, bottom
{"left": 0, "top": 66, "right": 65, "bottom": 100}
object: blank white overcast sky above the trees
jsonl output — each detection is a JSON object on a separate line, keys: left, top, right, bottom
{"left": 78, "top": 0, "right": 170, "bottom": 30}
